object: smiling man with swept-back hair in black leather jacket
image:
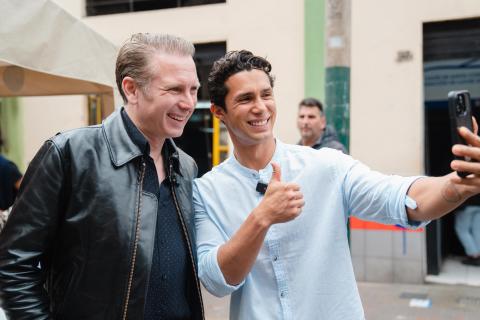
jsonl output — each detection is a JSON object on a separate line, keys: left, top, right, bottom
{"left": 0, "top": 34, "right": 203, "bottom": 319}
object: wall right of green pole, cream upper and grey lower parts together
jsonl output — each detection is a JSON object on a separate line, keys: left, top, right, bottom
{"left": 351, "top": 0, "right": 480, "bottom": 283}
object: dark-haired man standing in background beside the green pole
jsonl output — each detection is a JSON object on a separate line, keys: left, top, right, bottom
{"left": 297, "top": 98, "right": 347, "bottom": 153}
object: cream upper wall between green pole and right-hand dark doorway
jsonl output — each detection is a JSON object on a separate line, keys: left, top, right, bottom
{"left": 351, "top": 0, "right": 480, "bottom": 175}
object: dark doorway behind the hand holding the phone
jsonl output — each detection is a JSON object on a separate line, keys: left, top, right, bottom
{"left": 423, "top": 18, "right": 480, "bottom": 282}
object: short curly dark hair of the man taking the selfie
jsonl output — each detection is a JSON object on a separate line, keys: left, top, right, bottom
{"left": 208, "top": 50, "right": 274, "bottom": 112}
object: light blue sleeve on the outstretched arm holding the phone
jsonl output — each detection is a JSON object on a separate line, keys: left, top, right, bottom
{"left": 342, "top": 161, "right": 429, "bottom": 229}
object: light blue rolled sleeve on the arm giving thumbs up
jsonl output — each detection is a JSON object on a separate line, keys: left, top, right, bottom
{"left": 193, "top": 182, "right": 245, "bottom": 297}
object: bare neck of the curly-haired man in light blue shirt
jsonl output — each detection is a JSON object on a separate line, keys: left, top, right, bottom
{"left": 233, "top": 137, "right": 276, "bottom": 170}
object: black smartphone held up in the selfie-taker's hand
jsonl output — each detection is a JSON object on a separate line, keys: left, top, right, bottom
{"left": 448, "top": 90, "right": 473, "bottom": 178}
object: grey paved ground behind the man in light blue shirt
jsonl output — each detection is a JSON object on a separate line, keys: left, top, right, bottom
{"left": 204, "top": 282, "right": 480, "bottom": 320}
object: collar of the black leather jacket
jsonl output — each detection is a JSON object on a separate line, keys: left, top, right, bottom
{"left": 102, "top": 107, "right": 182, "bottom": 175}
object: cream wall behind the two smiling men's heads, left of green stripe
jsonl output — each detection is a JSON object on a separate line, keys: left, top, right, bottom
{"left": 56, "top": 0, "right": 304, "bottom": 142}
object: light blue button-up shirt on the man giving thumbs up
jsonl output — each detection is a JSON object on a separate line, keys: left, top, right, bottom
{"left": 193, "top": 140, "right": 423, "bottom": 320}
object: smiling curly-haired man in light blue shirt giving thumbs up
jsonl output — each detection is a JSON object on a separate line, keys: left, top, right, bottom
{"left": 193, "top": 51, "right": 480, "bottom": 320}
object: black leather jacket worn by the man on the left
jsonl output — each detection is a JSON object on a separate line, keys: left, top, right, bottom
{"left": 0, "top": 111, "right": 204, "bottom": 320}
